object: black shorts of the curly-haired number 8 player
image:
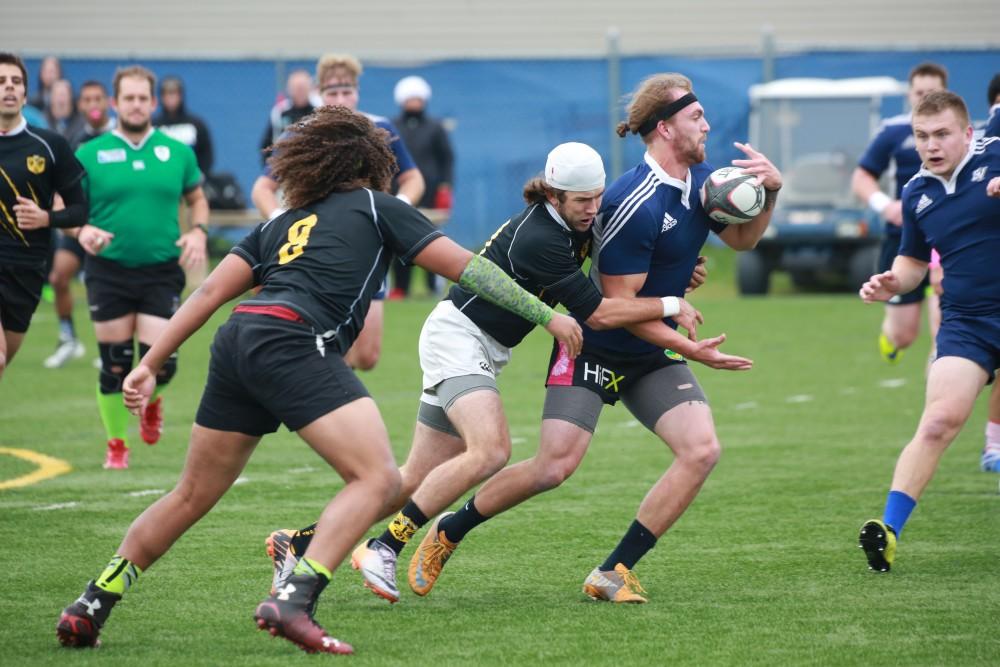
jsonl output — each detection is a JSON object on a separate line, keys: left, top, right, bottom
{"left": 195, "top": 313, "right": 368, "bottom": 436}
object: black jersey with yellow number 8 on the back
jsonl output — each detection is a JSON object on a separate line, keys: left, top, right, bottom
{"left": 231, "top": 188, "right": 442, "bottom": 354}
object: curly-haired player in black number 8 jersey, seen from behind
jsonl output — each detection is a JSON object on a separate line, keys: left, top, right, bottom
{"left": 57, "top": 107, "right": 582, "bottom": 653}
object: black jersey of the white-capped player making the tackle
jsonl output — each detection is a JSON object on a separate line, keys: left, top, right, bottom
{"left": 447, "top": 204, "right": 602, "bottom": 347}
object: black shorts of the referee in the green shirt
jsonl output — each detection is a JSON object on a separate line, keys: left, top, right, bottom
{"left": 85, "top": 255, "right": 185, "bottom": 322}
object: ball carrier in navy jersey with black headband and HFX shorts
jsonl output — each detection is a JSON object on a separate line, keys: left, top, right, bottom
{"left": 402, "top": 74, "right": 781, "bottom": 603}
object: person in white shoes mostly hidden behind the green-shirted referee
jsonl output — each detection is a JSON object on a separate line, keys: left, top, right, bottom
{"left": 42, "top": 81, "right": 115, "bottom": 368}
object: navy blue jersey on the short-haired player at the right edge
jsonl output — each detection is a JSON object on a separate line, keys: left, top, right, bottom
{"left": 899, "top": 137, "right": 1000, "bottom": 315}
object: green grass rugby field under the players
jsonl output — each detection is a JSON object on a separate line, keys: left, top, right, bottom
{"left": 0, "top": 250, "right": 1000, "bottom": 666}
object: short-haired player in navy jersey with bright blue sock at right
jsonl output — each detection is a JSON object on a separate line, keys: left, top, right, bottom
{"left": 859, "top": 91, "right": 1000, "bottom": 572}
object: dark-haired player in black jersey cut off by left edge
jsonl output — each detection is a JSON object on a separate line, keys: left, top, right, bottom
{"left": 0, "top": 53, "right": 87, "bottom": 377}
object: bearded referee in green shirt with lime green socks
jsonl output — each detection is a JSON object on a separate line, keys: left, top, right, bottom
{"left": 76, "top": 66, "right": 208, "bottom": 468}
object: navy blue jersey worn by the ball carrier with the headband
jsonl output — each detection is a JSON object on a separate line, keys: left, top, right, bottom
{"left": 578, "top": 153, "right": 727, "bottom": 354}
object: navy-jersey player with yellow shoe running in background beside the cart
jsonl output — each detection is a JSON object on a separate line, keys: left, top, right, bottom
{"left": 851, "top": 63, "right": 948, "bottom": 363}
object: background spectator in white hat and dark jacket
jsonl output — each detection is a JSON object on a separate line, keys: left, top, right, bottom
{"left": 389, "top": 76, "right": 455, "bottom": 299}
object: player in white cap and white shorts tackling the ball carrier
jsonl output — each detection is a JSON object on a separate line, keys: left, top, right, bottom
{"left": 262, "top": 143, "right": 701, "bottom": 602}
